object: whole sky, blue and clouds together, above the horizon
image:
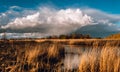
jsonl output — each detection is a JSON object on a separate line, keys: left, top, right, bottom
{"left": 0, "top": 0, "right": 120, "bottom": 37}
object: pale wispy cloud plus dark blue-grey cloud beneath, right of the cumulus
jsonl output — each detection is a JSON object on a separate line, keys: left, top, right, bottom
{"left": 74, "top": 8, "right": 120, "bottom": 37}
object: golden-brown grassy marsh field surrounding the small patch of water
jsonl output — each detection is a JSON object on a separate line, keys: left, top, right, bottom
{"left": 0, "top": 39, "right": 120, "bottom": 72}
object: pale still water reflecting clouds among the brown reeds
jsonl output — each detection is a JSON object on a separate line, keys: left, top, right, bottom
{"left": 64, "top": 45, "right": 90, "bottom": 70}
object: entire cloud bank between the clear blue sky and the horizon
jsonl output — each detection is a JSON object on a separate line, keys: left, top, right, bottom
{"left": 0, "top": 6, "right": 120, "bottom": 37}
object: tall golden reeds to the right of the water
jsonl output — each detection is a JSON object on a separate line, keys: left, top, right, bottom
{"left": 79, "top": 47, "right": 120, "bottom": 72}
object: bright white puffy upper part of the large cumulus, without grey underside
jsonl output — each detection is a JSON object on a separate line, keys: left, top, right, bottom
{"left": 2, "top": 8, "right": 92, "bottom": 29}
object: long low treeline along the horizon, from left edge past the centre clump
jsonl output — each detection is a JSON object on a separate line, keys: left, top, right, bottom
{"left": 0, "top": 34, "right": 101, "bottom": 40}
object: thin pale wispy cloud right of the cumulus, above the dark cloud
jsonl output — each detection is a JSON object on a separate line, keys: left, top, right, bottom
{"left": 82, "top": 8, "right": 120, "bottom": 30}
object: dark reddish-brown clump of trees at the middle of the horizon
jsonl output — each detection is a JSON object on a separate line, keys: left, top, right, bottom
{"left": 46, "top": 34, "right": 101, "bottom": 39}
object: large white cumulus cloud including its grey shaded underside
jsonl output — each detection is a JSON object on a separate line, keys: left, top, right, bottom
{"left": 1, "top": 7, "right": 92, "bottom": 34}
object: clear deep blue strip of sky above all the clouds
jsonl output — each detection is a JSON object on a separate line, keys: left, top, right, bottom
{"left": 0, "top": 0, "right": 120, "bottom": 14}
